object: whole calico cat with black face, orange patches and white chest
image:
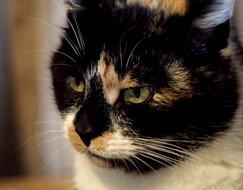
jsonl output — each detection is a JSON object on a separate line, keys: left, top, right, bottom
{"left": 50, "top": 0, "right": 243, "bottom": 190}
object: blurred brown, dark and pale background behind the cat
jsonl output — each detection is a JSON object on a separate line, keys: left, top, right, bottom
{"left": 0, "top": 0, "right": 243, "bottom": 190}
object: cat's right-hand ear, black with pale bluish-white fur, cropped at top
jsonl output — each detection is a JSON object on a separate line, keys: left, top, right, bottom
{"left": 188, "top": 0, "right": 234, "bottom": 52}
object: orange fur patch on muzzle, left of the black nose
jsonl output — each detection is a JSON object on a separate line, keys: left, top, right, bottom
{"left": 67, "top": 126, "right": 87, "bottom": 152}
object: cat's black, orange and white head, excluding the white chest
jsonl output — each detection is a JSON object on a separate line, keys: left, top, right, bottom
{"left": 51, "top": 0, "right": 238, "bottom": 172}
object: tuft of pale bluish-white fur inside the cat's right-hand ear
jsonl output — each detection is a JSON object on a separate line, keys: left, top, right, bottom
{"left": 194, "top": 0, "right": 235, "bottom": 29}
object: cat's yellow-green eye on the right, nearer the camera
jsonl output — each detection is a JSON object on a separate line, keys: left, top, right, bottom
{"left": 124, "top": 87, "right": 151, "bottom": 104}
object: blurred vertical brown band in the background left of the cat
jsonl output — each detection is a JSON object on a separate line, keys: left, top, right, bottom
{"left": 8, "top": 0, "right": 45, "bottom": 174}
